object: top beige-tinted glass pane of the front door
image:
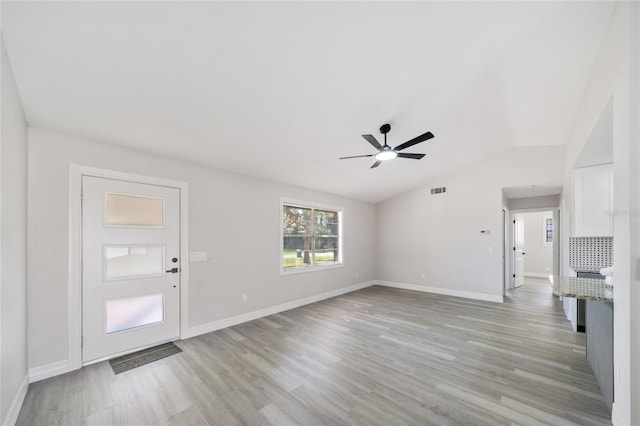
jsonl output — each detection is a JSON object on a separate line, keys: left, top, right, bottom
{"left": 105, "top": 192, "right": 164, "bottom": 227}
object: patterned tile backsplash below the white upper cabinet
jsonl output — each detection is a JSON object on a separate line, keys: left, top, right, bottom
{"left": 569, "top": 237, "right": 613, "bottom": 272}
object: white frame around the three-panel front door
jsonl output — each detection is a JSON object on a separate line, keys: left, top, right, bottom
{"left": 67, "top": 164, "right": 189, "bottom": 371}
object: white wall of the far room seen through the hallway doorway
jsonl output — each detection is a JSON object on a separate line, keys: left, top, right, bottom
{"left": 519, "top": 211, "right": 553, "bottom": 277}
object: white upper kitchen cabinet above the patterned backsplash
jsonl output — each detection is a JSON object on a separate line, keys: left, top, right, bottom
{"left": 573, "top": 164, "right": 613, "bottom": 237}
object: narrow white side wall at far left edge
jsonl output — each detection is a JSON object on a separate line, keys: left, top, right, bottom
{"left": 0, "top": 37, "right": 28, "bottom": 425}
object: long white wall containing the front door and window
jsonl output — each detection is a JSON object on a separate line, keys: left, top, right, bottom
{"left": 28, "top": 128, "right": 375, "bottom": 369}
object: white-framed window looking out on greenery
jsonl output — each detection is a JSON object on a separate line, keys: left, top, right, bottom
{"left": 281, "top": 201, "right": 342, "bottom": 272}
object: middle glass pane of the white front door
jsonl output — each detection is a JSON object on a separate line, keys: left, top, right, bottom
{"left": 103, "top": 245, "right": 164, "bottom": 280}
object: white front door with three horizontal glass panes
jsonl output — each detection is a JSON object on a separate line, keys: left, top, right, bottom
{"left": 82, "top": 176, "right": 180, "bottom": 362}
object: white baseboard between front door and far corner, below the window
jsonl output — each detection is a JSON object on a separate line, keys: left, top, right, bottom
{"left": 181, "top": 281, "right": 377, "bottom": 339}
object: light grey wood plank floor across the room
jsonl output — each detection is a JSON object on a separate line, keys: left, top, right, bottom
{"left": 17, "top": 280, "right": 610, "bottom": 425}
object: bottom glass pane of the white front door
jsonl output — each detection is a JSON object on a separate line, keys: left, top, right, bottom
{"left": 105, "top": 294, "right": 164, "bottom": 334}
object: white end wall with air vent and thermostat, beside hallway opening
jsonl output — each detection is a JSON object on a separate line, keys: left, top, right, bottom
{"left": 377, "top": 146, "right": 565, "bottom": 300}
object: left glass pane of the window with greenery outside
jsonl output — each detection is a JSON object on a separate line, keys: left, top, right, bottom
{"left": 282, "top": 206, "right": 313, "bottom": 268}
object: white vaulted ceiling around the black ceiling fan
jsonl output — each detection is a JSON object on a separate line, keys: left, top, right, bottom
{"left": 2, "top": 1, "right": 615, "bottom": 202}
